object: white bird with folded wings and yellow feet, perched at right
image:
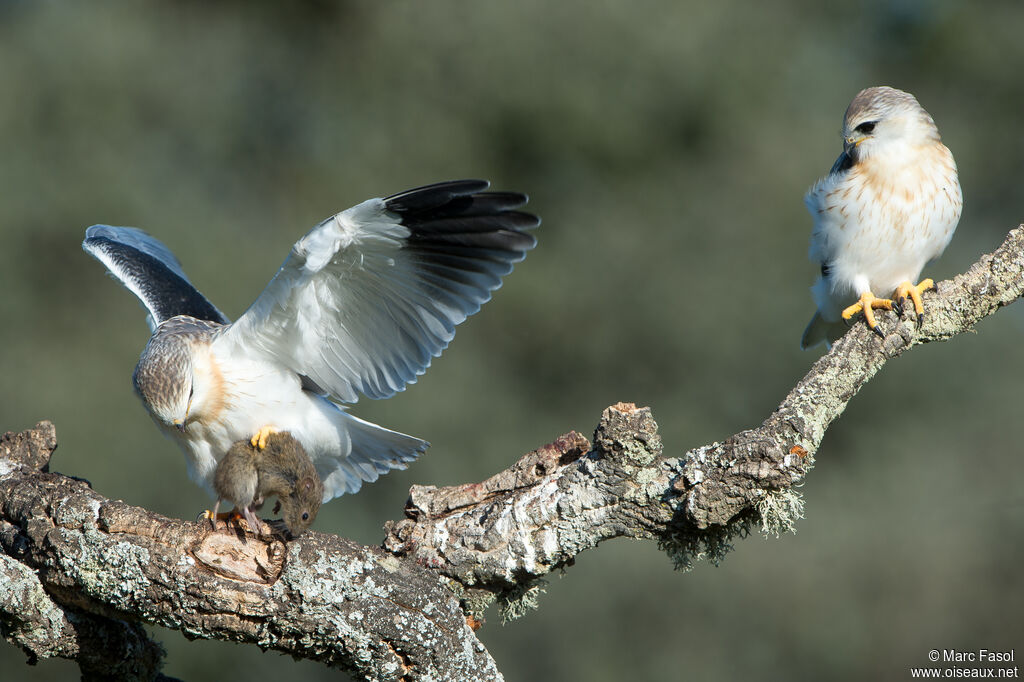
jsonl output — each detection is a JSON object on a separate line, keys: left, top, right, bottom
{"left": 801, "top": 87, "right": 963, "bottom": 348}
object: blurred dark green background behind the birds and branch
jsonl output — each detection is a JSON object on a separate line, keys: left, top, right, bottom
{"left": 0, "top": 0, "right": 1024, "bottom": 681}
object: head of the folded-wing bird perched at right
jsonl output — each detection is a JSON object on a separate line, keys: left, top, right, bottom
{"left": 843, "top": 87, "right": 939, "bottom": 163}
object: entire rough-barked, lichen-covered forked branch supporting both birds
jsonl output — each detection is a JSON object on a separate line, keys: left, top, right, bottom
{"left": 0, "top": 226, "right": 1024, "bottom": 680}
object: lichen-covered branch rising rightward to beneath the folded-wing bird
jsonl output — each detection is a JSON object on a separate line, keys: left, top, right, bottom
{"left": 385, "top": 225, "right": 1024, "bottom": 585}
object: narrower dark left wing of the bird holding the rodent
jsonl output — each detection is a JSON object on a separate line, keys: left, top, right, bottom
{"left": 82, "top": 225, "right": 230, "bottom": 330}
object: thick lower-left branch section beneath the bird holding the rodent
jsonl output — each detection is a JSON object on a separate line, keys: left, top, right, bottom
{"left": 0, "top": 425, "right": 500, "bottom": 680}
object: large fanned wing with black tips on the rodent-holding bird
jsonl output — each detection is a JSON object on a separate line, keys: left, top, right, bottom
{"left": 214, "top": 180, "right": 540, "bottom": 402}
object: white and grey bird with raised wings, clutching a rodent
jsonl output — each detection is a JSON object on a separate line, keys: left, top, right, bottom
{"left": 82, "top": 180, "right": 540, "bottom": 509}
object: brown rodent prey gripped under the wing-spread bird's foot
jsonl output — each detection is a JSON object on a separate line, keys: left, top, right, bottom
{"left": 210, "top": 431, "right": 324, "bottom": 538}
